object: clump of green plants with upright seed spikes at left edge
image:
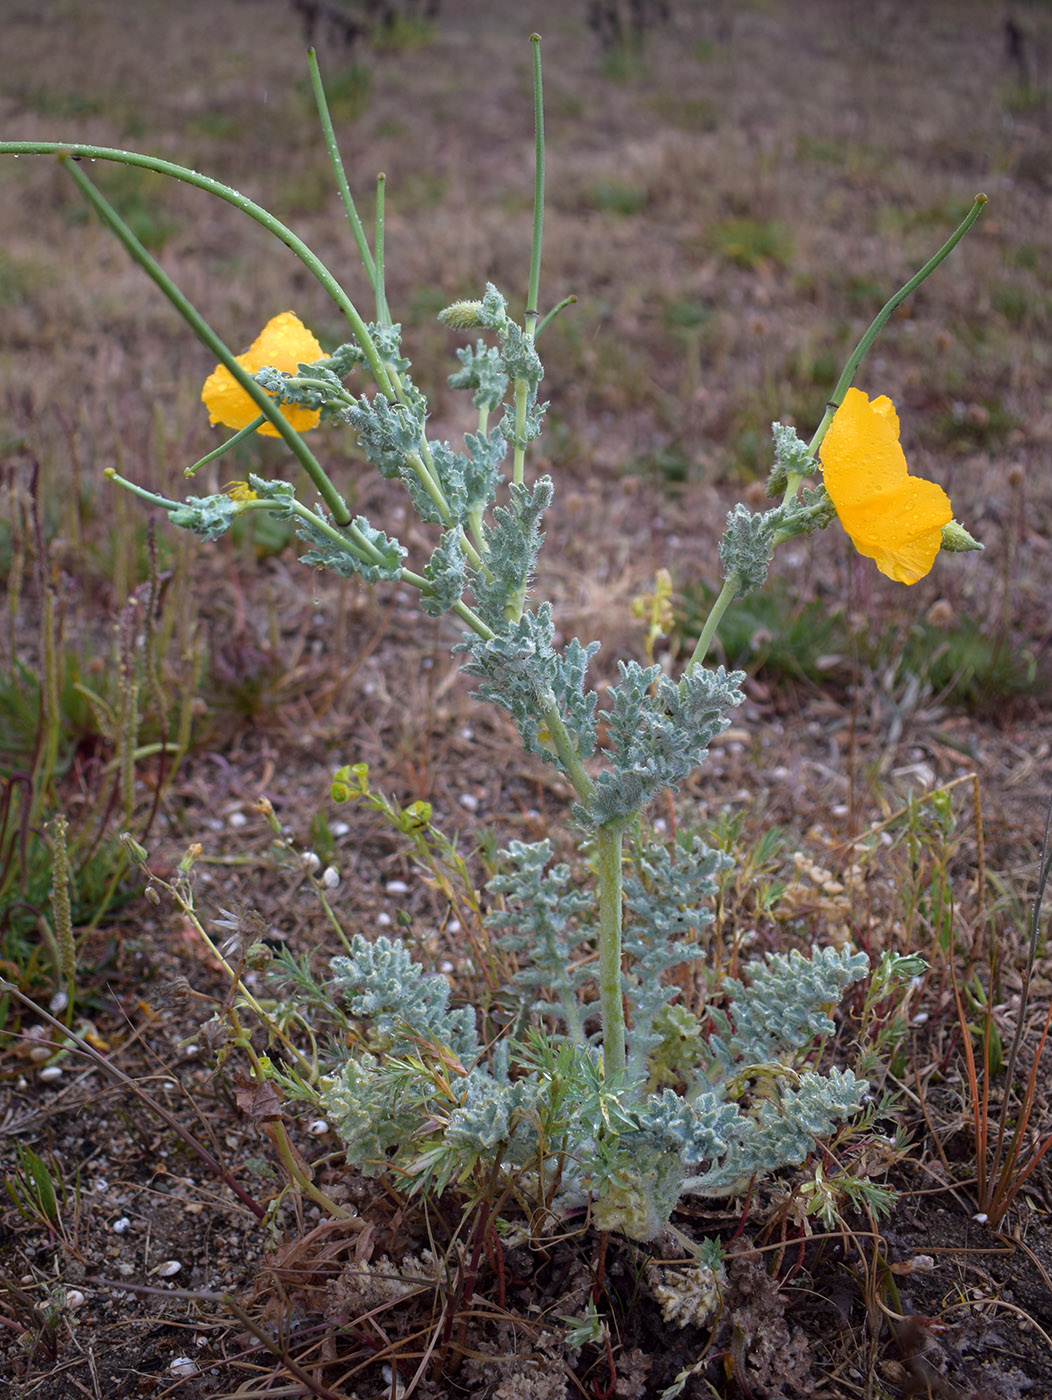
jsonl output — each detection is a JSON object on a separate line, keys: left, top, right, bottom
{"left": 0, "top": 480, "right": 198, "bottom": 1018}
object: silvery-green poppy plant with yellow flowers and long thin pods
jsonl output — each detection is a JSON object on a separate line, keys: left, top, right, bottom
{"left": 0, "top": 36, "right": 985, "bottom": 1254}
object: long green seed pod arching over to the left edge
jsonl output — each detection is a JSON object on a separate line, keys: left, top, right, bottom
{"left": 0, "top": 141, "right": 394, "bottom": 393}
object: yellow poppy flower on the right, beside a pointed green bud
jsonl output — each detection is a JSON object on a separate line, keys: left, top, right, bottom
{"left": 819, "top": 389, "right": 954, "bottom": 584}
